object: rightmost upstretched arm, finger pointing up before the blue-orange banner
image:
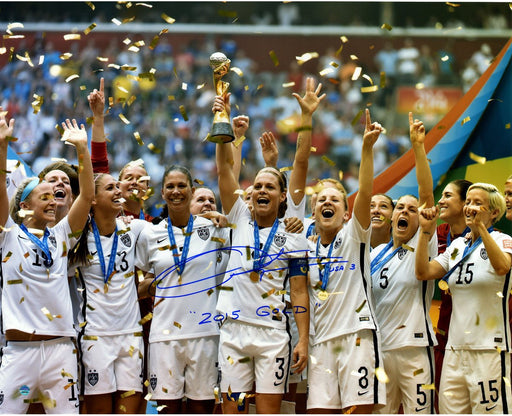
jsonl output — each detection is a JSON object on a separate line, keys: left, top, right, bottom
{"left": 409, "top": 113, "right": 434, "bottom": 207}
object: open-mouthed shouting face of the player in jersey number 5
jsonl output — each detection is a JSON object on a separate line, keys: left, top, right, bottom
{"left": 391, "top": 195, "right": 419, "bottom": 245}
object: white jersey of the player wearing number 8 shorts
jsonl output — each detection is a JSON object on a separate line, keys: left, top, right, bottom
{"left": 308, "top": 216, "right": 377, "bottom": 344}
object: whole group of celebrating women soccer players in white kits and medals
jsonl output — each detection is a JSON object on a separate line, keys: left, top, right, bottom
{"left": 0, "top": 73, "right": 512, "bottom": 414}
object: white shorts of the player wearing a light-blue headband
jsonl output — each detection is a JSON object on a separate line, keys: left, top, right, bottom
{"left": 0, "top": 337, "right": 79, "bottom": 414}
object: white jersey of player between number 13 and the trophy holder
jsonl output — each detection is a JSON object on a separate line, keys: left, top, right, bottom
{"left": 136, "top": 216, "right": 229, "bottom": 342}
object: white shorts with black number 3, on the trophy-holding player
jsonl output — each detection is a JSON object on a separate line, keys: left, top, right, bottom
{"left": 219, "top": 319, "right": 291, "bottom": 394}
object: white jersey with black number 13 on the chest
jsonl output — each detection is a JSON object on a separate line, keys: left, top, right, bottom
{"left": 74, "top": 219, "right": 149, "bottom": 335}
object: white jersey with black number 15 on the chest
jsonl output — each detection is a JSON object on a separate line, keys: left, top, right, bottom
{"left": 434, "top": 231, "right": 512, "bottom": 351}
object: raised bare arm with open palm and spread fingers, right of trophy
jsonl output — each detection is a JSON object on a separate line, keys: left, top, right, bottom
{"left": 288, "top": 77, "right": 325, "bottom": 205}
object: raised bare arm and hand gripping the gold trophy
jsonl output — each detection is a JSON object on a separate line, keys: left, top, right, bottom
{"left": 213, "top": 96, "right": 239, "bottom": 214}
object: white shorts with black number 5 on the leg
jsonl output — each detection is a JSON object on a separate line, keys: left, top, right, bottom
{"left": 374, "top": 347, "right": 435, "bottom": 414}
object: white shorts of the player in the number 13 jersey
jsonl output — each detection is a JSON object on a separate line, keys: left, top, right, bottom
{"left": 80, "top": 333, "right": 144, "bottom": 395}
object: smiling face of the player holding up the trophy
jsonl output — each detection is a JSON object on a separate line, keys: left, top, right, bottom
{"left": 251, "top": 171, "right": 286, "bottom": 218}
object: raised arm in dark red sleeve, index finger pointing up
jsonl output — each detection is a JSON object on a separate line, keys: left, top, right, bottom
{"left": 87, "top": 78, "right": 109, "bottom": 173}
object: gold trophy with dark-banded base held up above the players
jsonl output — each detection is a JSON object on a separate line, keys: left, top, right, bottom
{"left": 208, "top": 52, "right": 235, "bottom": 143}
